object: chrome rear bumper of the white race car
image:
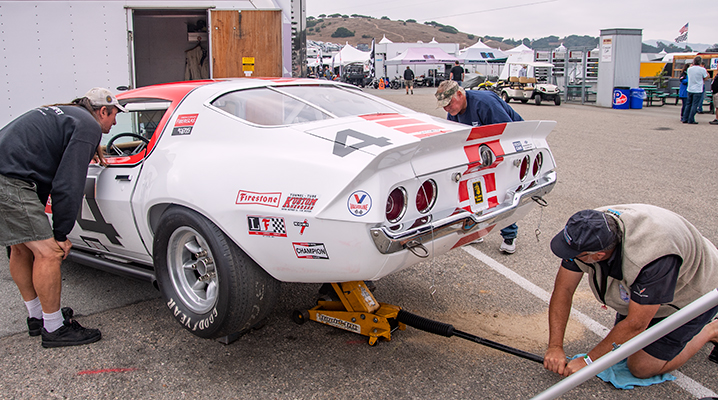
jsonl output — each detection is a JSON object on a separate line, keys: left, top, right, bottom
{"left": 370, "top": 171, "right": 556, "bottom": 254}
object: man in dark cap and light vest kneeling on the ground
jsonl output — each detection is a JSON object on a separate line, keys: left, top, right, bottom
{"left": 544, "top": 204, "right": 718, "bottom": 379}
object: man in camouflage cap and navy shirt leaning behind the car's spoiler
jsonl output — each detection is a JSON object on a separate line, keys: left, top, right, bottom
{"left": 434, "top": 81, "right": 523, "bottom": 254}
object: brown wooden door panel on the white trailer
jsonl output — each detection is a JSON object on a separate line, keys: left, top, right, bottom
{"left": 210, "top": 10, "right": 282, "bottom": 78}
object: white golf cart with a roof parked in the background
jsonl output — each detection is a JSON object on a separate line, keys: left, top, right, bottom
{"left": 494, "top": 62, "right": 561, "bottom": 106}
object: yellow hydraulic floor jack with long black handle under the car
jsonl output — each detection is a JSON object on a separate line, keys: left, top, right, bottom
{"left": 292, "top": 281, "right": 543, "bottom": 363}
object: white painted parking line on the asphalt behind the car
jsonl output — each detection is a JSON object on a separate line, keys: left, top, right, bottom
{"left": 462, "top": 246, "right": 718, "bottom": 398}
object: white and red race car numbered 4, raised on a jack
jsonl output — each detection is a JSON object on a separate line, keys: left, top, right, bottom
{"left": 59, "top": 78, "right": 556, "bottom": 338}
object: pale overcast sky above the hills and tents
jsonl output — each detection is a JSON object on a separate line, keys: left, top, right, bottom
{"left": 306, "top": 0, "right": 718, "bottom": 44}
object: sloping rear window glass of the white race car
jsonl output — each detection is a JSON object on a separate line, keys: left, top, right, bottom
{"left": 212, "top": 85, "right": 397, "bottom": 126}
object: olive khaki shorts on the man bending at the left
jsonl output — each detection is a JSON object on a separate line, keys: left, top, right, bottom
{"left": 0, "top": 175, "right": 54, "bottom": 246}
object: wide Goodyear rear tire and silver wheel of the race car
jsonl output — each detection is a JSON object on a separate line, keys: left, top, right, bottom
{"left": 153, "top": 207, "right": 279, "bottom": 338}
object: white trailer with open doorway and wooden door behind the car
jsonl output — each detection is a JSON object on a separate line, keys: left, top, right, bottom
{"left": 0, "top": 0, "right": 306, "bottom": 127}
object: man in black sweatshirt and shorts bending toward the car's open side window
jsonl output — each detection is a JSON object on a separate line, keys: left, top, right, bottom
{"left": 0, "top": 88, "right": 124, "bottom": 347}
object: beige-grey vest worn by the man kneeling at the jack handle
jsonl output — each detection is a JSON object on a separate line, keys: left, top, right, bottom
{"left": 575, "top": 204, "right": 718, "bottom": 317}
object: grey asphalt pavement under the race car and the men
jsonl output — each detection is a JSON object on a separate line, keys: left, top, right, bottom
{"left": 0, "top": 88, "right": 718, "bottom": 399}
